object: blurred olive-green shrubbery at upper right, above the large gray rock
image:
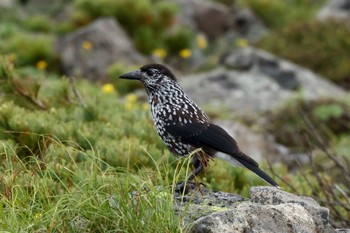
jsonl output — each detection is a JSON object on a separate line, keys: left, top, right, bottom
{"left": 241, "top": 0, "right": 350, "bottom": 88}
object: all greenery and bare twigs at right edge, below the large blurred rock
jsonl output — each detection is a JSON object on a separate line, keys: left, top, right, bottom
{"left": 264, "top": 99, "right": 350, "bottom": 227}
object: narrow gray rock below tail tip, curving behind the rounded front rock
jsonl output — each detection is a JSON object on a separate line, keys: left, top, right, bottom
{"left": 250, "top": 186, "right": 330, "bottom": 232}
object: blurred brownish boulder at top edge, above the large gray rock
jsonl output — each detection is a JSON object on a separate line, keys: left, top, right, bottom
{"left": 175, "top": 0, "right": 266, "bottom": 43}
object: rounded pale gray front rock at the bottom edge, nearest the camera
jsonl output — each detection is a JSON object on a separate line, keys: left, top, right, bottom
{"left": 192, "top": 202, "right": 317, "bottom": 233}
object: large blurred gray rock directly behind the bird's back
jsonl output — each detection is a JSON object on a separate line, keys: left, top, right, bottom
{"left": 180, "top": 48, "right": 345, "bottom": 115}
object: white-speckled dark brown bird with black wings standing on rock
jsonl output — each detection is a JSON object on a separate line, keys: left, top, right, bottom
{"left": 119, "top": 63, "right": 279, "bottom": 192}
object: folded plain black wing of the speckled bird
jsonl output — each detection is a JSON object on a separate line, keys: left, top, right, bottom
{"left": 166, "top": 123, "right": 259, "bottom": 166}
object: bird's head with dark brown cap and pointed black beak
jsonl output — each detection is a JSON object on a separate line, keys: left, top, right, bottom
{"left": 119, "top": 64, "right": 176, "bottom": 89}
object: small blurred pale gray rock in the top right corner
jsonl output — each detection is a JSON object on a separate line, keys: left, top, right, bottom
{"left": 317, "top": 0, "right": 350, "bottom": 25}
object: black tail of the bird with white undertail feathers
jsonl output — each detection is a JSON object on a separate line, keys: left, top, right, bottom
{"left": 216, "top": 152, "right": 279, "bottom": 188}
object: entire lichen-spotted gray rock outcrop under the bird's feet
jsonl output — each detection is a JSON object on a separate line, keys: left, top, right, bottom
{"left": 175, "top": 186, "right": 336, "bottom": 233}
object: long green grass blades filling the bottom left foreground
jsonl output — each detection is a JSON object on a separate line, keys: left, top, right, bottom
{"left": 0, "top": 136, "right": 191, "bottom": 232}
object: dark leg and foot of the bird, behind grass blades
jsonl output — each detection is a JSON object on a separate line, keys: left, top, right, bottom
{"left": 175, "top": 154, "right": 203, "bottom": 194}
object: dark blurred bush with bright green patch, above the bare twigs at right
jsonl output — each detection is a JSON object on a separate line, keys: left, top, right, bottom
{"left": 266, "top": 99, "right": 350, "bottom": 151}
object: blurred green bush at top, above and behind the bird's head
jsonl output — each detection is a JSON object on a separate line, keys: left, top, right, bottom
{"left": 75, "top": 0, "right": 193, "bottom": 55}
